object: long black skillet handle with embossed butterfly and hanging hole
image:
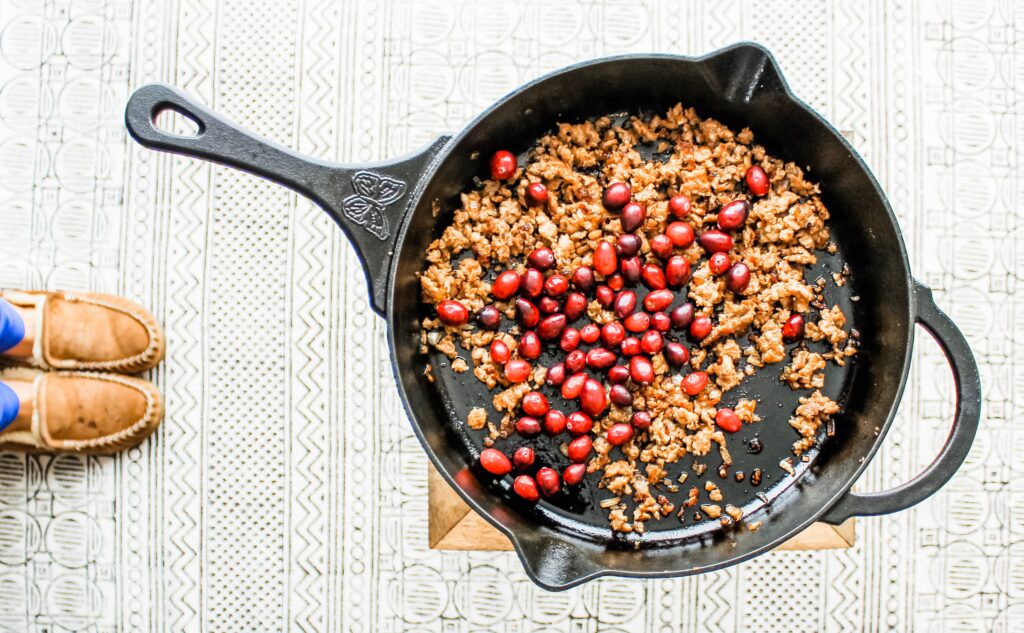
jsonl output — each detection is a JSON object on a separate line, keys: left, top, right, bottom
{"left": 125, "top": 84, "right": 449, "bottom": 314}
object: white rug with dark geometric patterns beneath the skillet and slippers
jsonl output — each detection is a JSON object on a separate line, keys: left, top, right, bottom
{"left": 0, "top": 0, "right": 1011, "bottom": 633}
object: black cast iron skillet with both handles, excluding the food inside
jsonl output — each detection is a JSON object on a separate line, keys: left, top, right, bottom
{"left": 125, "top": 44, "right": 981, "bottom": 590}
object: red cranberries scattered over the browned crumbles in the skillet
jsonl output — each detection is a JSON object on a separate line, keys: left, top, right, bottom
{"left": 437, "top": 152, "right": 782, "bottom": 501}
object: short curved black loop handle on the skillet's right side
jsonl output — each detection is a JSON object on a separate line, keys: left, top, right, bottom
{"left": 821, "top": 282, "right": 981, "bottom": 525}
